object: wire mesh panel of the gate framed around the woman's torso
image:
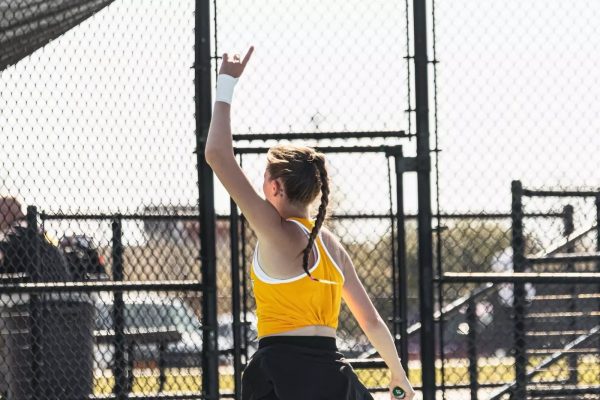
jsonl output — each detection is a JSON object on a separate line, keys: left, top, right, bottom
{"left": 225, "top": 145, "right": 418, "bottom": 391}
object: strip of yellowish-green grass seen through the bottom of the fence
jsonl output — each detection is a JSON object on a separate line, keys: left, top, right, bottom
{"left": 94, "top": 356, "right": 600, "bottom": 394}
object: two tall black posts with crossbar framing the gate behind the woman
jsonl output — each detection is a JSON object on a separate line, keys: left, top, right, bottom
{"left": 205, "top": 0, "right": 437, "bottom": 400}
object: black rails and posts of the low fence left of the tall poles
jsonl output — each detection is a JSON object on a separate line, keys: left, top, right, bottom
{"left": 0, "top": 206, "right": 206, "bottom": 400}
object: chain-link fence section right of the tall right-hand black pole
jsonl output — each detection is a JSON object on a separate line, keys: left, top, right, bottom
{"left": 432, "top": 0, "right": 600, "bottom": 398}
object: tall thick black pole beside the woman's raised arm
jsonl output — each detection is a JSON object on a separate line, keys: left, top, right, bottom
{"left": 194, "top": 0, "right": 219, "bottom": 400}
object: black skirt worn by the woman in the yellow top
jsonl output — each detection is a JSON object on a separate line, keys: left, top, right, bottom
{"left": 242, "top": 336, "right": 373, "bottom": 400}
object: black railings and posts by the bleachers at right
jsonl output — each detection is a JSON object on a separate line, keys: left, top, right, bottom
{"left": 436, "top": 181, "right": 600, "bottom": 400}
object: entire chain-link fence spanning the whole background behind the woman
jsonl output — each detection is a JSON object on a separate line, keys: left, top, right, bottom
{"left": 0, "top": 0, "right": 600, "bottom": 400}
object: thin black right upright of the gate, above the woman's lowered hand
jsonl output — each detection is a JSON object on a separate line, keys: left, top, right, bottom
{"left": 394, "top": 149, "right": 408, "bottom": 373}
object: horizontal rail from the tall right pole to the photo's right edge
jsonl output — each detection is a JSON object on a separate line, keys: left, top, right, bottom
{"left": 437, "top": 272, "right": 600, "bottom": 284}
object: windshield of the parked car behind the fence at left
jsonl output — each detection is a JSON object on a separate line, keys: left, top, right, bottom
{"left": 96, "top": 299, "right": 200, "bottom": 332}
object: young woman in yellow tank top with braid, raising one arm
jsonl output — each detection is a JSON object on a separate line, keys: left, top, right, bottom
{"left": 205, "top": 47, "right": 414, "bottom": 400}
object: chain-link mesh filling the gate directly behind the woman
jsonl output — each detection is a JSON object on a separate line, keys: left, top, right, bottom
{"left": 231, "top": 148, "right": 418, "bottom": 394}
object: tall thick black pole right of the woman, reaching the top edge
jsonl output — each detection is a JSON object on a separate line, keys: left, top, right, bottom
{"left": 413, "top": 0, "right": 436, "bottom": 400}
